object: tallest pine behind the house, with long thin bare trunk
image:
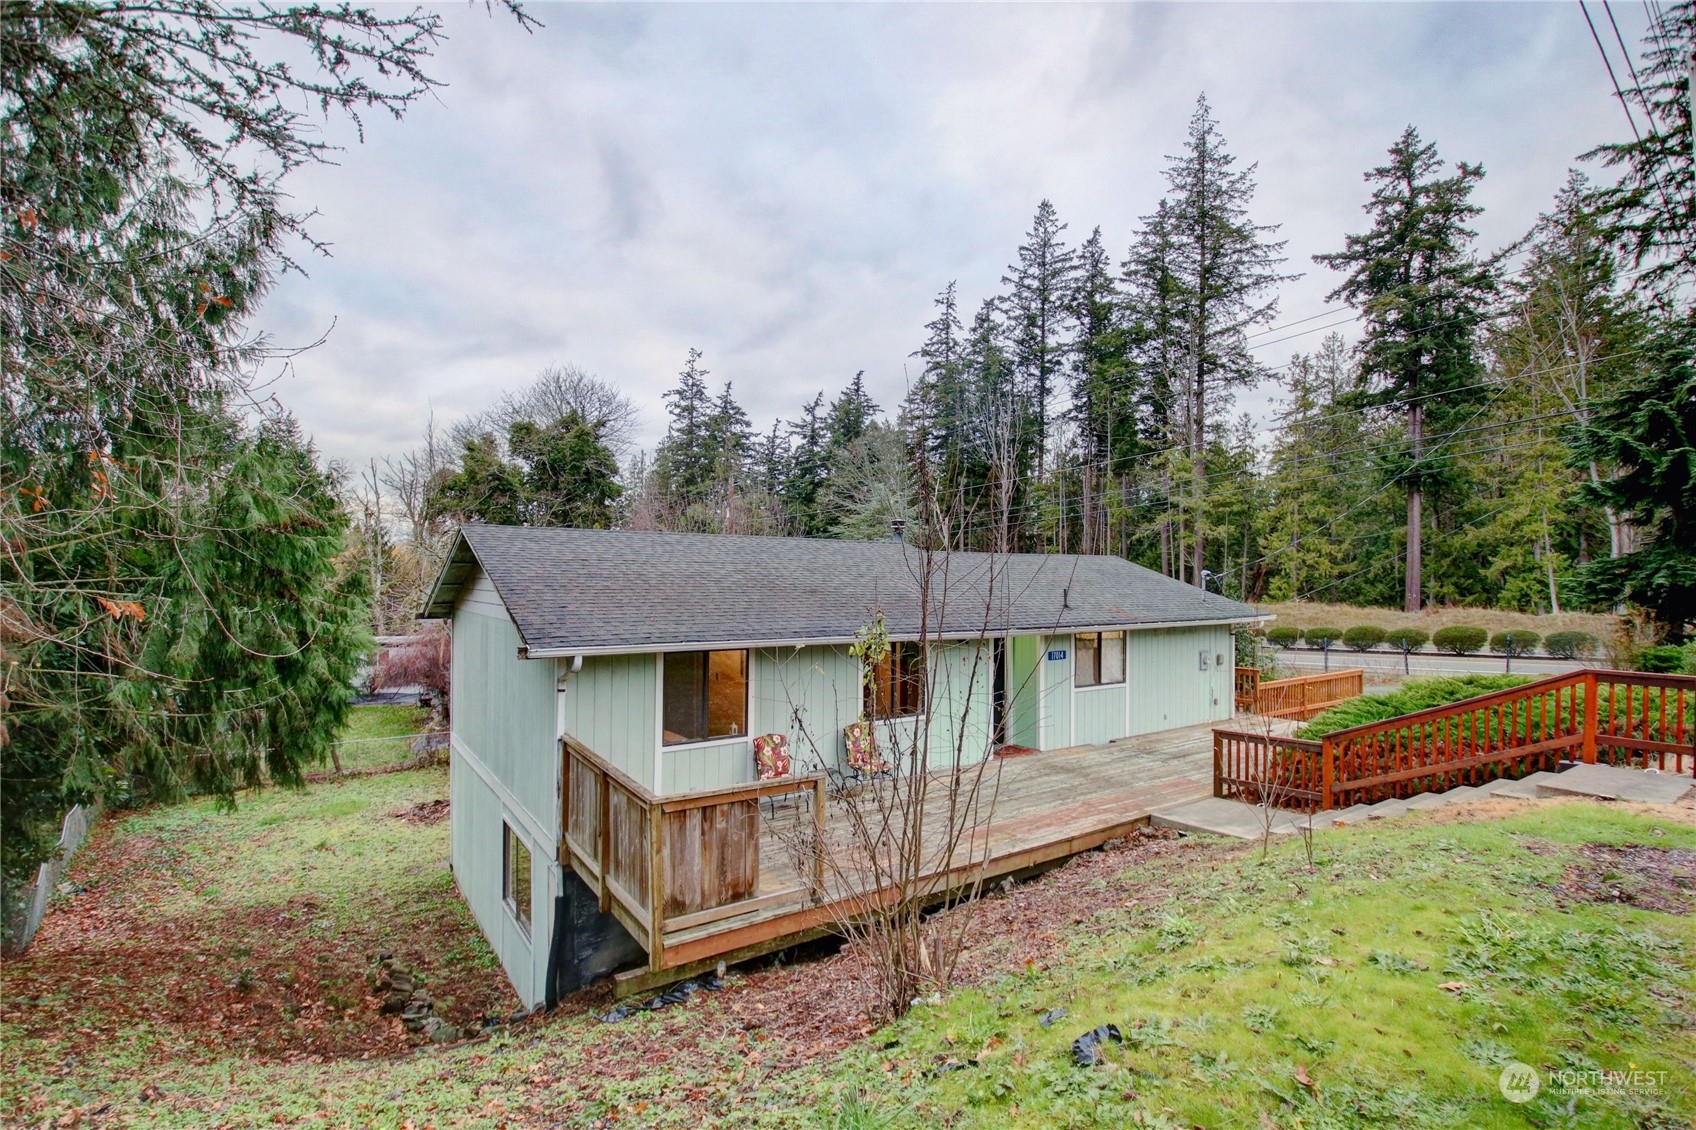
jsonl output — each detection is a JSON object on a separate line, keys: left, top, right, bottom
{"left": 1165, "top": 95, "right": 1289, "bottom": 585}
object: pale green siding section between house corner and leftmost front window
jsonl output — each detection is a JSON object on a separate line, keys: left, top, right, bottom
{"left": 560, "top": 655, "right": 660, "bottom": 789}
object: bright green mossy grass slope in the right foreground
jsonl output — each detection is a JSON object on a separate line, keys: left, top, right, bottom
{"left": 807, "top": 803, "right": 1696, "bottom": 1130}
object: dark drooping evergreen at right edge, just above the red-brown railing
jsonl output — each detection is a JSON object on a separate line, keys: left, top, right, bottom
{"left": 1574, "top": 310, "right": 1696, "bottom": 643}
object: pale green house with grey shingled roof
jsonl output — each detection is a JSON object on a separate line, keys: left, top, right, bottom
{"left": 426, "top": 526, "right": 1258, "bottom": 1004}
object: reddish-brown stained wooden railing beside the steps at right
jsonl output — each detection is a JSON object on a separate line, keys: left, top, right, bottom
{"left": 1213, "top": 670, "right": 1696, "bottom": 809}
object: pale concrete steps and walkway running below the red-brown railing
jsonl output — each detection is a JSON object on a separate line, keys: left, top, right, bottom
{"left": 1150, "top": 765, "right": 1696, "bottom": 840}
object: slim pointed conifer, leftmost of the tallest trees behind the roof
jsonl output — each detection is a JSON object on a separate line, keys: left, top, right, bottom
{"left": 1001, "top": 200, "right": 1077, "bottom": 467}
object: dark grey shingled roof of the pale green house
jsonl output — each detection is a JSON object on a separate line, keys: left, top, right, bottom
{"left": 424, "top": 526, "right": 1258, "bottom": 653}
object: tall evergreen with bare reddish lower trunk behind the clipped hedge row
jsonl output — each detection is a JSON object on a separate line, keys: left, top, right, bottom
{"left": 1313, "top": 126, "right": 1496, "bottom": 613}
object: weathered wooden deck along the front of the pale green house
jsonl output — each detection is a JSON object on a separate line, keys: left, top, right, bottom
{"left": 561, "top": 719, "right": 1294, "bottom": 993}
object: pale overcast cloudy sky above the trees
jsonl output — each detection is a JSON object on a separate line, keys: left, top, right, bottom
{"left": 261, "top": 3, "right": 1642, "bottom": 462}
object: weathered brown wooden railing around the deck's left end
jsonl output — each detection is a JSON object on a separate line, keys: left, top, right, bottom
{"left": 560, "top": 738, "right": 824, "bottom": 971}
